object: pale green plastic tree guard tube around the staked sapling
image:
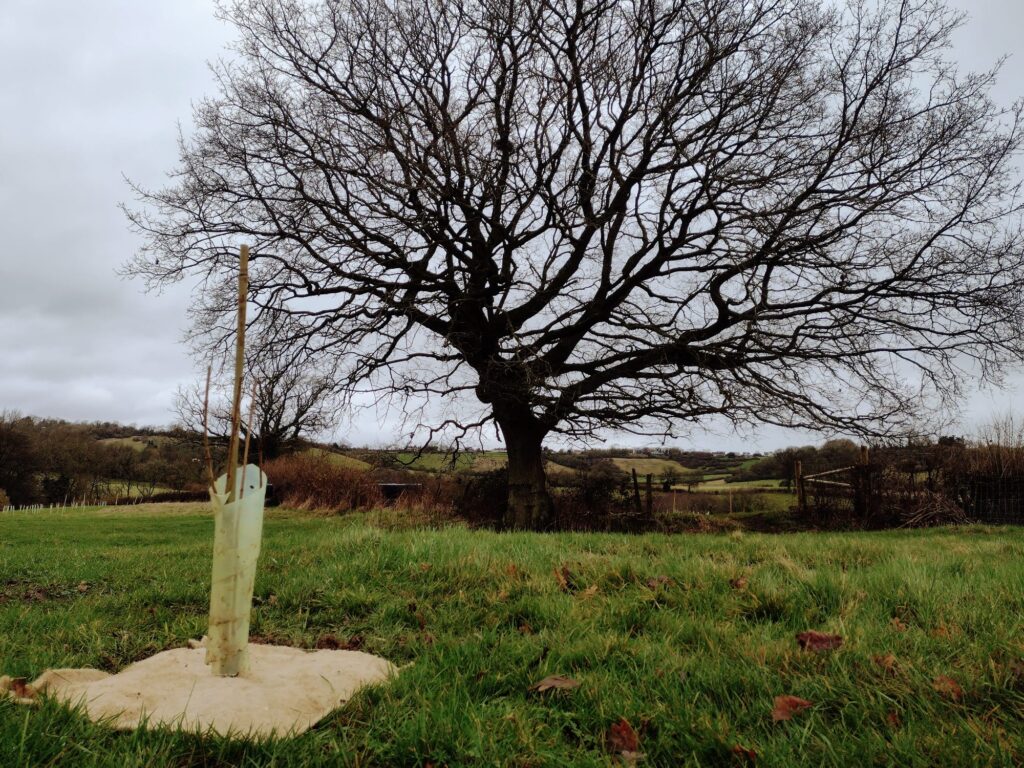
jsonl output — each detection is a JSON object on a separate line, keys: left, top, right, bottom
{"left": 206, "top": 464, "right": 266, "bottom": 677}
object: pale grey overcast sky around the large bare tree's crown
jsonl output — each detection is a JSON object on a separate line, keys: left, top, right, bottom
{"left": 0, "top": 0, "right": 1024, "bottom": 450}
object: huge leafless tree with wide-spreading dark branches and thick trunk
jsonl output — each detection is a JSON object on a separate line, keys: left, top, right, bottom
{"left": 129, "top": 0, "right": 1022, "bottom": 528}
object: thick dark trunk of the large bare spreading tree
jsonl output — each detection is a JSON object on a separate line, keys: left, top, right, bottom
{"left": 496, "top": 409, "right": 555, "bottom": 530}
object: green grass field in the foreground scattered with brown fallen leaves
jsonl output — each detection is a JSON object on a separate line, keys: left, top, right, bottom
{"left": 0, "top": 505, "right": 1024, "bottom": 767}
